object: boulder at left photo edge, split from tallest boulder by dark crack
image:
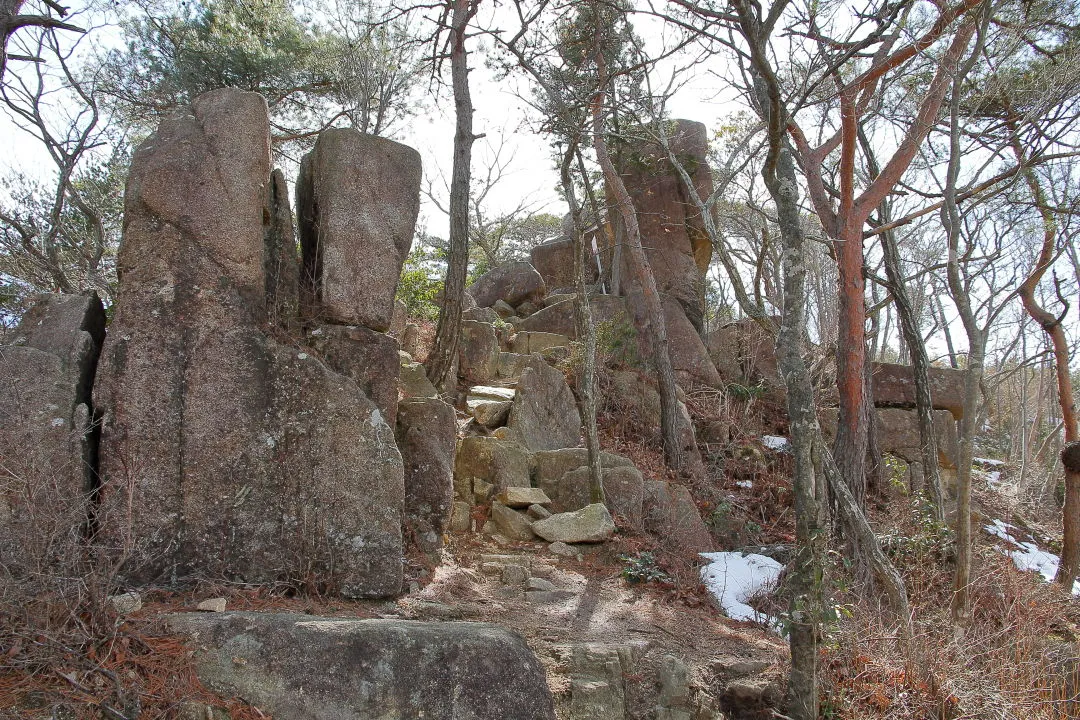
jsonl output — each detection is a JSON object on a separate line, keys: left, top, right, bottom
{"left": 0, "top": 295, "right": 105, "bottom": 587}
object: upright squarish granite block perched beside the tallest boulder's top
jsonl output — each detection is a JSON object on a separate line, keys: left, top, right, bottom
{"left": 296, "top": 128, "right": 420, "bottom": 331}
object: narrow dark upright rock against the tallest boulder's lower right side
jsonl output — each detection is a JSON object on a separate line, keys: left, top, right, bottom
{"left": 395, "top": 397, "right": 458, "bottom": 552}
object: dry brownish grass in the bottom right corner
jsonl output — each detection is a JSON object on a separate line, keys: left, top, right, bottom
{"left": 823, "top": 505, "right": 1080, "bottom": 720}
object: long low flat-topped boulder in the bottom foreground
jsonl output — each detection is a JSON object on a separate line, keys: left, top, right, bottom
{"left": 168, "top": 613, "right": 555, "bottom": 720}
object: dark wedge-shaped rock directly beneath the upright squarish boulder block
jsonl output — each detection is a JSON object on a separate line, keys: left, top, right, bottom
{"left": 308, "top": 325, "right": 401, "bottom": 427}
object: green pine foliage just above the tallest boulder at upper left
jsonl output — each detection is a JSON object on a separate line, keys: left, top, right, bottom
{"left": 104, "top": 0, "right": 420, "bottom": 139}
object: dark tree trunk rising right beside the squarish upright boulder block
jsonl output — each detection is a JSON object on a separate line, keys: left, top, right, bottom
{"left": 427, "top": 0, "right": 477, "bottom": 393}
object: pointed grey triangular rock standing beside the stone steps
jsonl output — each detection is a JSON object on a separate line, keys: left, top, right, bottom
{"left": 508, "top": 357, "right": 581, "bottom": 451}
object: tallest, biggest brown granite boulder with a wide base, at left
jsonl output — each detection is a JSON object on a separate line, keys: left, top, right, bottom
{"left": 94, "top": 90, "right": 404, "bottom": 597}
